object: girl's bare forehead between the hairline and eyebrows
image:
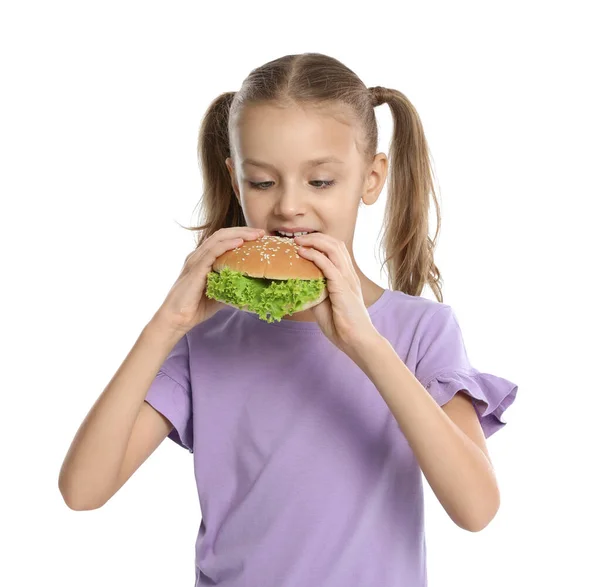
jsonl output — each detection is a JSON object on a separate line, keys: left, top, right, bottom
{"left": 232, "top": 104, "right": 359, "bottom": 168}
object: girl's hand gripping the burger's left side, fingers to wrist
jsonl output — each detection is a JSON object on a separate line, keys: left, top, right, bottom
{"left": 152, "top": 226, "right": 265, "bottom": 334}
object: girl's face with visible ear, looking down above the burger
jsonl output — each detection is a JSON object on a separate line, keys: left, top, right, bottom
{"left": 226, "top": 105, "right": 387, "bottom": 251}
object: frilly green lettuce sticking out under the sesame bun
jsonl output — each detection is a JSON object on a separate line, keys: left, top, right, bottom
{"left": 206, "top": 267, "right": 325, "bottom": 322}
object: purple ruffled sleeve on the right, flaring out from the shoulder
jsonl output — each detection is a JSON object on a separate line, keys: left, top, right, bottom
{"left": 415, "top": 304, "right": 518, "bottom": 438}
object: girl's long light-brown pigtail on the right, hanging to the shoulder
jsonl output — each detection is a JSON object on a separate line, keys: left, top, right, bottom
{"left": 369, "top": 86, "right": 443, "bottom": 302}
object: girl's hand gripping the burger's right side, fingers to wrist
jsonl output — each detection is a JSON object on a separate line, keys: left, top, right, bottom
{"left": 294, "top": 232, "right": 379, "bottom": 357}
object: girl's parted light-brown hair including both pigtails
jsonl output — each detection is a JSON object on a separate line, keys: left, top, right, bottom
{"left": 182, "top": 53, "right": 443, "bottom": 302}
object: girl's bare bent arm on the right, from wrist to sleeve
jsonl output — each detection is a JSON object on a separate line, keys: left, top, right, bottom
{"left": 352, "top": 337, "right": 499, "bottom": 531}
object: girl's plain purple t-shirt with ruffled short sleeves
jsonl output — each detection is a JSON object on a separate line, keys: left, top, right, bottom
{"left": 146, "top": 289, "right": 518, "bottom": 587}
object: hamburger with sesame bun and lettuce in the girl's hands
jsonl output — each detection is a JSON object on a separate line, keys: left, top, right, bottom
{"left": 206, "top": 235, "right": 328, "bottom": 322}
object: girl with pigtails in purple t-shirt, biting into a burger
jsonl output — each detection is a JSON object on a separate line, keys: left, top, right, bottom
{"left": 60, "top": 53, "right": 517, "bottom": 587}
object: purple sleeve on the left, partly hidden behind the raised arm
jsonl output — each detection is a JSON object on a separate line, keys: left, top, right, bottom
{"left": 145, "top": 334, "right": 194, "bottom": 452}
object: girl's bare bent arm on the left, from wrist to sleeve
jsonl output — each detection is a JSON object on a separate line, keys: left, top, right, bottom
{"left": 58, "top": 320, "right": 182, "bottom": 510}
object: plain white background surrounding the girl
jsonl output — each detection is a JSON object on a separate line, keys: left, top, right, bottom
{"left": 0, "top": 1, "right": 600, "bottom": 587}
